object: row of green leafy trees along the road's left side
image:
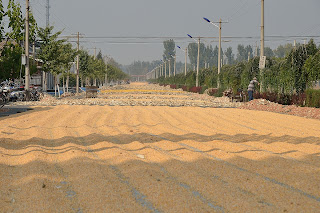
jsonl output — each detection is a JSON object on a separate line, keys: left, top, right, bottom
{"left": 0, "top": 0, "right": 128, "bottom": 90}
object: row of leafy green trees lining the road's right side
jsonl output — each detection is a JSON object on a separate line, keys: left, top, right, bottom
{"left": 157, "top": 39, "right": 320, "bottom": 94}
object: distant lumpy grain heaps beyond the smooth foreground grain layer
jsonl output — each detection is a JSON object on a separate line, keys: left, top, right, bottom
{"left": 9, "top": 84, "right": 240, "bottom": 107}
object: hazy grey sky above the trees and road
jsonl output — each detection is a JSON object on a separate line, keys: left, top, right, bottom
{"left": 3, "top": 0, "right": 320, "bottom": 65}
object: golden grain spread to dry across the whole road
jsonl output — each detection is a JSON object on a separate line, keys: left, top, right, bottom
{"left": 0, "top": 82, "right": 320, "bottom": 212}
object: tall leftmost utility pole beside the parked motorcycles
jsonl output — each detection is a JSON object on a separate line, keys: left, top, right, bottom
{"left": 24, "top": 0, "right": 30, "bottom": 101}
